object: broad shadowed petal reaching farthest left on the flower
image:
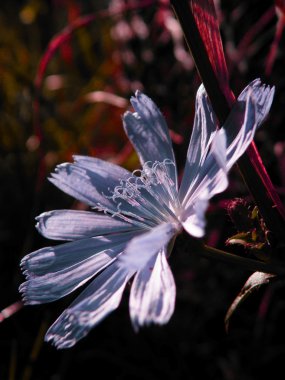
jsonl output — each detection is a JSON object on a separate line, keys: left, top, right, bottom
{"left": 20, "top": 233, "right": 138, "bottom": 304}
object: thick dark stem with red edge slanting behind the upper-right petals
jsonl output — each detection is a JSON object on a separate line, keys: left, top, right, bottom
{"left": 170, "top": 0, "right": 285, "bottom": 242}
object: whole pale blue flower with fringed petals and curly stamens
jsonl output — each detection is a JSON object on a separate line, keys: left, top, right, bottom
{"left": 20, "top": 80, "right": 274, "bottom": 348}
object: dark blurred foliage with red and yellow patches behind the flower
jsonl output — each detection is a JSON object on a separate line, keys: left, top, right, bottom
{"left": 0, "top": 0, "right": 285, "bottom": 380}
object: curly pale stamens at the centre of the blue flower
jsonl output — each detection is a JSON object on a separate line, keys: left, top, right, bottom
{"left": 96, "top": 159, "right": 180, "bottom": 228}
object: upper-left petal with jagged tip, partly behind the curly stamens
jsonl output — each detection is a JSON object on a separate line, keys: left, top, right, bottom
{"left": 49, "top": 156, "right": 158, "bottom": 226}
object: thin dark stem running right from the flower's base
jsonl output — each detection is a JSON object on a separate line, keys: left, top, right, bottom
{"left": 201, "top": 245, "right": 285, "bottom": 276}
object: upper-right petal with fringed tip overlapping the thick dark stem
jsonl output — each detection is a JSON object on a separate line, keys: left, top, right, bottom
{"left": 179, "top": 79, "right": 274, "bottom": 208}
